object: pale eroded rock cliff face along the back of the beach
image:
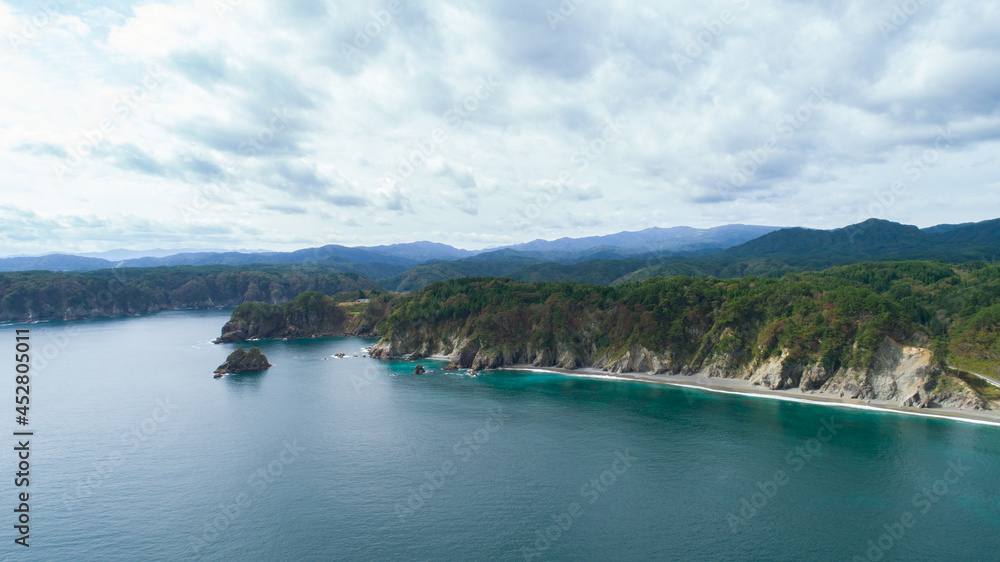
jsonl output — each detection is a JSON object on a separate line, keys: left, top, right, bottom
{"left": 371, "top": 330, "right": 1000, "bottom": 410}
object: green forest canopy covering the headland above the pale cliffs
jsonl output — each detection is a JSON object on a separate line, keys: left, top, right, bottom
{"left": 378, "top": 262, "right": 1000, "bottom": 377}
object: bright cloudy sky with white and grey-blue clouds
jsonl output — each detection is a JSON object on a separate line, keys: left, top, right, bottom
{"left": 0, "top": 0, "right": 1000, "bottom": 255}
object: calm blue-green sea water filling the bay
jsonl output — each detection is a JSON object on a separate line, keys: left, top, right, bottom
{"left": 0, "top": 311, "right": 1000, "bottom": 560}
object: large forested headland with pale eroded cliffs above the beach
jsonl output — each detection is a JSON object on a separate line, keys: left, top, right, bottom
{"left": 368, "top": 262, "right": 1000, "bottom": 407}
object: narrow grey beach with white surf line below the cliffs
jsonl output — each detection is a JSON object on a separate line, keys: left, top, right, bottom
{"left": 488, "top": 364, "right": 1000, "bottom": 427}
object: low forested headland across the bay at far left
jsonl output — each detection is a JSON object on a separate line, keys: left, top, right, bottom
{"left": 0, "top": 265, "right": 380, "bottom": 322}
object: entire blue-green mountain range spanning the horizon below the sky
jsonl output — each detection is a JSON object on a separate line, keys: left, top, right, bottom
{"left": 0, "top": 219, "right": 1000, "bottom": 292}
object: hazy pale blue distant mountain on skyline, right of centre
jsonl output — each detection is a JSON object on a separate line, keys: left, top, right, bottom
{"left": 507, "top": 224, "right": 779, "bottom": 253}
